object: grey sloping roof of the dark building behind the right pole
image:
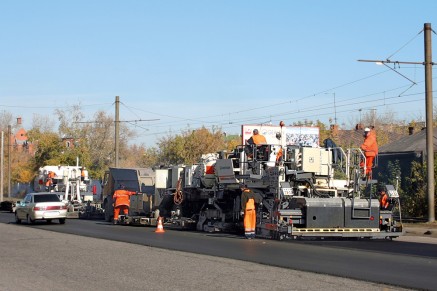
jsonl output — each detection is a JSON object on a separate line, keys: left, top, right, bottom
{"left": 379, "top": 128, "right": 437, "bottom": 153}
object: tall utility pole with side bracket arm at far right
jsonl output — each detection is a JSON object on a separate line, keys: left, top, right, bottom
{"left": 358, "top": 23, "right": 435, "bottom": 222}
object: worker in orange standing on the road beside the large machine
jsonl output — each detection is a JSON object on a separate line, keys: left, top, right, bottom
{"left": 241, "top": 185, "right": 262, "bottom": 239}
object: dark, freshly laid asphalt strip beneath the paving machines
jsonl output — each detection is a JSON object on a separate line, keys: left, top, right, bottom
{"left": 0, "top": 213, "right": 437, "bottom": 290}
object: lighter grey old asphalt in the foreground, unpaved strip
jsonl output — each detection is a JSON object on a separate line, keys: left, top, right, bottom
{"left": 0, "top": 223, "right": 408, "bottom": 291}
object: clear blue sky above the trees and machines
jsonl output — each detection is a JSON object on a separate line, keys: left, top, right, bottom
{"left": 0, "top": 0, "right": 437, "bottom": 146}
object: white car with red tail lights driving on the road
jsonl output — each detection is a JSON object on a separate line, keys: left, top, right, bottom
{"left": 15, "top": 192, "right": 67, "bottom": 224}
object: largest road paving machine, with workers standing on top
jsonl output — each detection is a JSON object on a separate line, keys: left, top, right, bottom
{"left": 155, "top": 126, "right": 402, "bottom": 239}
